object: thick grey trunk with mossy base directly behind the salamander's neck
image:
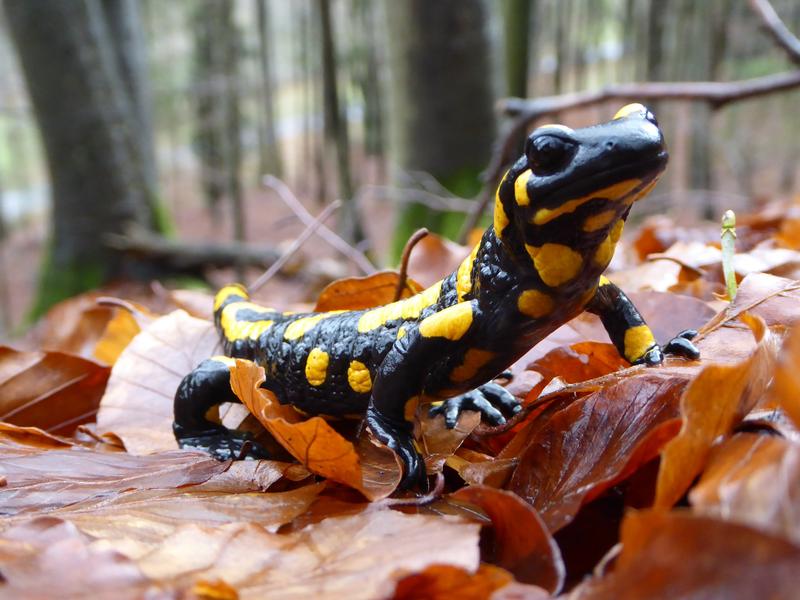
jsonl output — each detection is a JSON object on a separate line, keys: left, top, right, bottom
{"left": 385, "top": 0, "right": 495, "bottom": 257}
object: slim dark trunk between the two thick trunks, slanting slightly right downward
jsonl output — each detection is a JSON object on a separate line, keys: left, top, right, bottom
{"left": 317, "top": 0, "right": 364, "bottom": 243}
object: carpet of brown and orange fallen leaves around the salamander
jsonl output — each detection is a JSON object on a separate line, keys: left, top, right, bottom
{"left": 0, "top": 217, "right": 800, "bottom": 599}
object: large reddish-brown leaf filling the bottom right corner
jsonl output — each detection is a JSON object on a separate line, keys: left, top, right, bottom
{"left": 570, "top": 511, "right": 800, "bottom": 600}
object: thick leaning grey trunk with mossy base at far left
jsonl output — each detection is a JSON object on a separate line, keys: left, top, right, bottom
{"left": 5, "top": 0, "right": 169, "bottom": 315}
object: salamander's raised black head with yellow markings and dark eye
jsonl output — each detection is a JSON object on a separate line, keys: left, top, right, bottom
{"left": 494, "top": 104, "right": 668, "bottom": 273}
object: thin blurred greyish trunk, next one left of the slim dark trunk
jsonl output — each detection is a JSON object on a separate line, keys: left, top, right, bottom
{"left": 255, "top": 0, "right": 283, "bottom": 177}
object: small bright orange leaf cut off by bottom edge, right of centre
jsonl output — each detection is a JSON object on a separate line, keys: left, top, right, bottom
{"left": 392, "top": 565, "right": 513, "bottom": 600}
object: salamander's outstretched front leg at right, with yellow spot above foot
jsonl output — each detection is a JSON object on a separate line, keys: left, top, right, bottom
{"left": 586, "top": 277, "right": 700, "bottom": 366}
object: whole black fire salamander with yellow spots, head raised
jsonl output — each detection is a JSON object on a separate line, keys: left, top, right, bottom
{"left": 174, "top": 104, "right": 699, "bottom": 489}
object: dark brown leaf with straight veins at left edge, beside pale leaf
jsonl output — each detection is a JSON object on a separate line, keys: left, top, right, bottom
{"left": 0, "top": 346, "right": 109, "bottom": 435}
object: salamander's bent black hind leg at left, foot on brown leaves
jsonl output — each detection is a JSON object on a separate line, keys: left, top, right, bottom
{"left": 172, "top": 356, "right": 269, "bottom": 460}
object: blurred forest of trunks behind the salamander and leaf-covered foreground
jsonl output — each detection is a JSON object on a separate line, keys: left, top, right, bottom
{"left": 0, "top": 0, "right": 800, "bottom": 339}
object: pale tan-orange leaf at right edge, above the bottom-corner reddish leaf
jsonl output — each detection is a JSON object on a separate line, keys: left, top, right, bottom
{"left": 689, "top": 433, "right": 800, "bottom": 543}
